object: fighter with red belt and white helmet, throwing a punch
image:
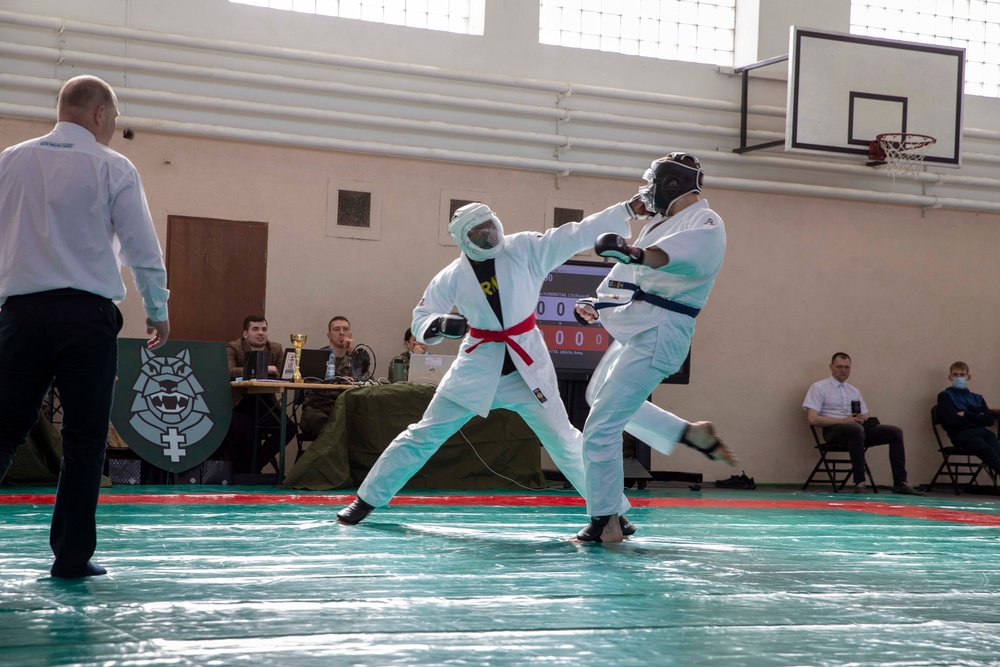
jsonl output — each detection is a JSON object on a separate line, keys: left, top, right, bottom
{"left": 337, "top": 204, "right": 634, "bottom": 534}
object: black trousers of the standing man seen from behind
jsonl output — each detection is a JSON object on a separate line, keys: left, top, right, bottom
{"left": 0, "top": 290, "right": 122, "bottom": 571}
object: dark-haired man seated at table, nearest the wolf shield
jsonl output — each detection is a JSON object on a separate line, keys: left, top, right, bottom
{"left": 226, "top": 315, "right": 295, "bottom": 473}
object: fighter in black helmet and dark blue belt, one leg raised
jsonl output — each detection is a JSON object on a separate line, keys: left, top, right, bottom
{"left": 577, "top": 153, "right": 736, "bottom": 542}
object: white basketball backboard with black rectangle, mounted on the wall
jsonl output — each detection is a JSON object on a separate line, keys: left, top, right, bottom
{"left": 785, "top": 26, "right": 965, "bottom": 167}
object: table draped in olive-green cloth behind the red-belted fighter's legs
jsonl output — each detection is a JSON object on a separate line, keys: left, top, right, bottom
{"left": 284, "top": 383, "right": 545, "bottom": 491}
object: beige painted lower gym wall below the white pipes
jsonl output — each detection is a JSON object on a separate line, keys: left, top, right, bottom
{"left": 0, "top": 119, "right": 1000, "bottom": 483}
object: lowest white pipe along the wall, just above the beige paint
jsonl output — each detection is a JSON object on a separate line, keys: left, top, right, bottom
{"left": 0, "top": 103, "right": 1000, "bottom": 213}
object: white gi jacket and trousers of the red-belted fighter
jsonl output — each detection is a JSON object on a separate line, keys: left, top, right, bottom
{"left": 358, "top": 204, "right": 630, "bottom": 513}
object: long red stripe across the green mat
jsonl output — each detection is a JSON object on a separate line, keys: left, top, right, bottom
{"left": 0, "top": 493, "right": 1000, "bottom": 526}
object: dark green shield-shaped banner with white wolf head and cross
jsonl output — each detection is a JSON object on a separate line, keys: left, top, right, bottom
{"left": 111, "top": 338, "right": 233, "bottom": 472}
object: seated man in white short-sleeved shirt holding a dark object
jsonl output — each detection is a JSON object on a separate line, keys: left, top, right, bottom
{"left": 802, "top": 352, "right": 923, "bottom": 496}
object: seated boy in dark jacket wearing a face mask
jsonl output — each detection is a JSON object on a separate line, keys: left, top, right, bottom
{"left": 938, "top": 361, "right": 1000, "bottom": 474}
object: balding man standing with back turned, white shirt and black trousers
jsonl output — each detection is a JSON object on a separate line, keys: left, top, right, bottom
{"left": 0, "top": 76, "right": 170, "bottom": 578}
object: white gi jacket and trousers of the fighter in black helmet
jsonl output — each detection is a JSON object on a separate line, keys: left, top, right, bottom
{"left": 583, "top": 200, "right": 726, "bottom": 516}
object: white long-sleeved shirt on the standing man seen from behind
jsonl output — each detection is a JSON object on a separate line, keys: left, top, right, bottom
{"left": 0, "top": 122, "right": 169, "bottom": 322}
